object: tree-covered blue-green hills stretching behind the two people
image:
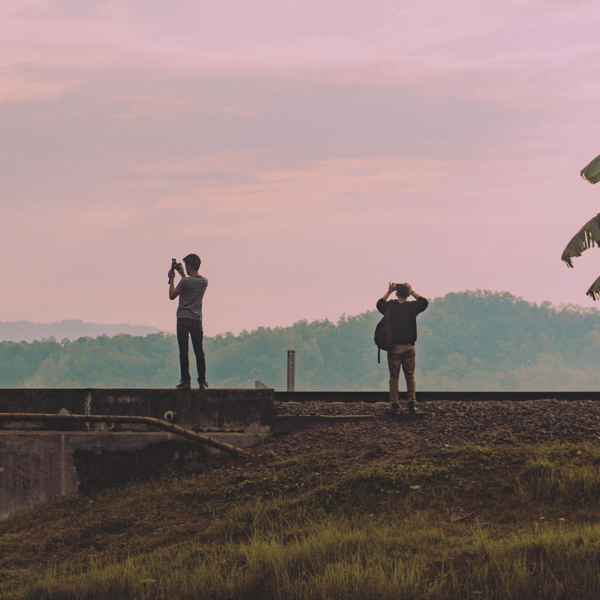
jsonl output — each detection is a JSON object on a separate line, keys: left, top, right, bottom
{"left": 0, "top": 292, "right": 600, "bottom": 390}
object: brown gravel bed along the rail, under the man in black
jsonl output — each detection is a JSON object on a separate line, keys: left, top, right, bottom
{"left": 255, "top": 400, "right": 600, "bottom": 465}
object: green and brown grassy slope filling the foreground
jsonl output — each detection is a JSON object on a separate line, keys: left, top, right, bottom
{"left": 0, "top": 444, "right": 600, "bottom": 600}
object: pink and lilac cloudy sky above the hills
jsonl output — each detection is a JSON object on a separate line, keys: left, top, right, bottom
{"left": 0, "top": 0, "right": 600, "bottom": 334}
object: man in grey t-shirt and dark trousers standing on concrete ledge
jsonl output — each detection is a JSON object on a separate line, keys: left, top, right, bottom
{"left": 168, "top": 254, "right": 208, "bottom": 390}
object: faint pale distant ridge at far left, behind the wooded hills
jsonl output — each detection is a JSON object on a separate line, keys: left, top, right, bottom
{"left": 0, "top": 319, "right": 160, "bottom": 342}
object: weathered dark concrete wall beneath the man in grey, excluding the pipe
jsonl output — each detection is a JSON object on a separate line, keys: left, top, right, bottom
{"left": 0, "top": 389, "right": 275, "bottom": 519}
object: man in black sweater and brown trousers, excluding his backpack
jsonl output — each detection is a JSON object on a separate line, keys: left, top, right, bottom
{"left": 377, "top": 282, "right": 429, "bottom": 413}
